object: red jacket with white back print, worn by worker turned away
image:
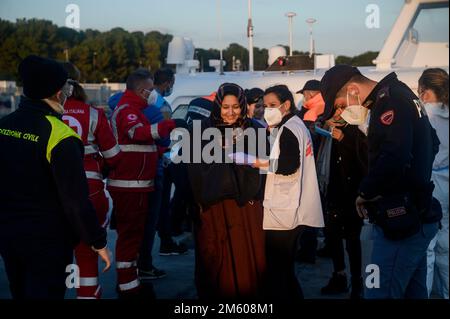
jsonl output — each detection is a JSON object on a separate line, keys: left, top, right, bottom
{"left": 62, "top": 98, "right": 121, "bottom": 194}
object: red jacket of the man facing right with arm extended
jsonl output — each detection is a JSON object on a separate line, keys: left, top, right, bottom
{"left": 107, "top": 90, "right": 175, "bottom": 192}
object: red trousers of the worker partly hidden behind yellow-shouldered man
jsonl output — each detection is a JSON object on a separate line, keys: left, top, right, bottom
{"left": 75, "top": 188, "right": 109, "bottom": 299}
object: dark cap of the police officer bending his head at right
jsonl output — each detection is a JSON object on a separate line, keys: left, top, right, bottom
{"left": 320, "top": 64, "right": 361, "bottom": 121}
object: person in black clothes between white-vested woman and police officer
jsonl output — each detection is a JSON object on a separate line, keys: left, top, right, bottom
{"left": 321, "top": 108, "right": 368, "bottom": 299}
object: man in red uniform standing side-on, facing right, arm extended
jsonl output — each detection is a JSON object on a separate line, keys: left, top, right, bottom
{"left": 107, "top": 69, "right": 179, "bottom": 298}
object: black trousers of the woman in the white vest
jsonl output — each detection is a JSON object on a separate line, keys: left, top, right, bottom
{"left": 266, "top": 226, "right": 304, "bottom": 301}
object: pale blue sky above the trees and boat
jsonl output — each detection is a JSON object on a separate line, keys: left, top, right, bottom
{"left": 0, "top": 0, "right": 449, "bottom": 56}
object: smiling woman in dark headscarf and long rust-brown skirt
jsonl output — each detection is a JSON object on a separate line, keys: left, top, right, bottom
{"left": 187, "top": 83, "right": 266, "bottom": 299}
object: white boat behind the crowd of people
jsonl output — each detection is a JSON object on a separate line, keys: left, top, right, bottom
{"left": 167, "top": 0, "right": 449, "bottom": 117}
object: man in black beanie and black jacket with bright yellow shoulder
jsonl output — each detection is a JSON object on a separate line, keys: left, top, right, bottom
{"left": 0, "top": 55, "right": 110, "bottom": 299}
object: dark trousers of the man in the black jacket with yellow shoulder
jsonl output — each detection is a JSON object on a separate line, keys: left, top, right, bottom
{"left": 0, "top": 238, "right": 73, "bottom": 299}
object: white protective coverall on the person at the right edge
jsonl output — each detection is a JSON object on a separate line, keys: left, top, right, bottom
{"left": 425, "top": 103, "right": 449, "bottom": 299}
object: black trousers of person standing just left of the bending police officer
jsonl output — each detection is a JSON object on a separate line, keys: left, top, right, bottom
{"left": 327, "top": 212, "right": 362, "bottom": 278}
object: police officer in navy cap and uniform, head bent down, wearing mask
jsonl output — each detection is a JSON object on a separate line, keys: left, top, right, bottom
{"left": 321, "top": 65, "right": 442, "bottom": 299}
